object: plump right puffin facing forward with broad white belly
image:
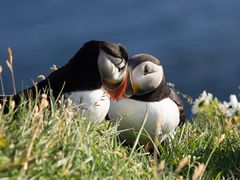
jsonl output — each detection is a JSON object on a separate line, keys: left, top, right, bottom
{"left": 108, "top": 54, "right": 185, "bottom": 146}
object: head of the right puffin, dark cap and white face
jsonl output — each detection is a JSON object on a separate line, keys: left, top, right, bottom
{"left": 125, "top": 54, "right": 165, "bottom": 97}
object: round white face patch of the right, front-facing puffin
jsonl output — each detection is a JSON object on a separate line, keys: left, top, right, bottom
{"left": 126, "top": 61, "right": 164, "bottom": 96}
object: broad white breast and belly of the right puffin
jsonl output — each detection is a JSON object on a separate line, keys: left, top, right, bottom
{"left": 108, "top": 98, "right": 180, "bottom": 142}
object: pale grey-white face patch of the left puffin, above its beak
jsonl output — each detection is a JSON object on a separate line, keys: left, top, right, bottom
{"left": 98, "top": 49, "right": 127, "bottom": 84}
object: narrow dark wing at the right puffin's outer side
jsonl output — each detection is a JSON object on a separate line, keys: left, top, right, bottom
{"left": 167, "top": 83, "right": 186, "bottom": 125}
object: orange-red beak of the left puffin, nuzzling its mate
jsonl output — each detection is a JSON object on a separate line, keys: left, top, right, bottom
{"left": 104, "top": 75, "right": 127, "bottom": 100}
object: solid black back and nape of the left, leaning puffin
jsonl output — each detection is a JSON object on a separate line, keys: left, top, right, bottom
{"left": 0, "top": 40, "right": 101, "bottom": 104}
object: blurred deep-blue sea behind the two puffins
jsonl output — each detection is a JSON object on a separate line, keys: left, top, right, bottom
{"left": 0, "top": 0, "right": 240, "bottom": 114}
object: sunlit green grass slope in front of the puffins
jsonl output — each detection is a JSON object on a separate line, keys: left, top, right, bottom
{"left": 0, "top": 94, "right": 240, "bottom": 179}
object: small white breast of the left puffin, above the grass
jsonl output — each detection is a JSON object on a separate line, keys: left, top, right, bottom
{"left": 64, "top": 88, "right": 110, "bottom": 122}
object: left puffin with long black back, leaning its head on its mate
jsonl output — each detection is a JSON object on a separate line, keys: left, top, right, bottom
{"left": 0, "top": 40, "right": 128, "bottom": 122}
